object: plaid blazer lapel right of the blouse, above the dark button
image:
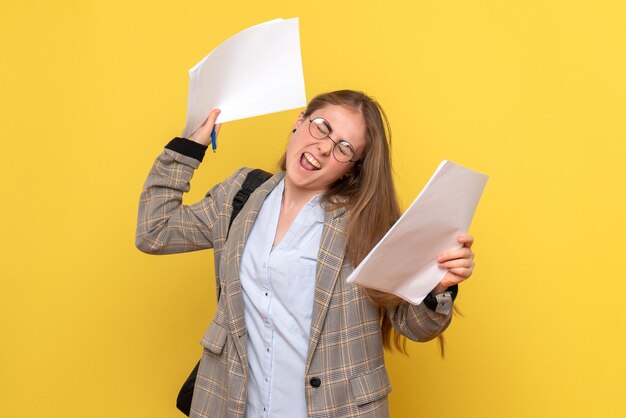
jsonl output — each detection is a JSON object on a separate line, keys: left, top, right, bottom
{"left": 305, "top": 204, "right": 347, "bottom": 373}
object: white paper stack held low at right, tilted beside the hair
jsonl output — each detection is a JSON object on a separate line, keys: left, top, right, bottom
{"left": 347, "top": 161, "right": 489, "bottom": 304}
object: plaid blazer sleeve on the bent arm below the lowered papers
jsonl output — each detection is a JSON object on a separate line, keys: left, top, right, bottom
{"left": 386, "top": 301, "right": 452, "bottom": 342}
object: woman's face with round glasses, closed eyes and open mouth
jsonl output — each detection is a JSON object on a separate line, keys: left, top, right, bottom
{"left": 285, "top": 105, "right": 365, "bottom": 196}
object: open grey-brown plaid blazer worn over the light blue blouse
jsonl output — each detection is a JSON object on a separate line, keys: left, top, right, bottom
{"left": 136, "top": 149, "right": 450, "bottom": 418}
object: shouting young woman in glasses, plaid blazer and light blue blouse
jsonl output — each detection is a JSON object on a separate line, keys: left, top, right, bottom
{"left": 136, "top": 90, "right": 474, "bottom": 418}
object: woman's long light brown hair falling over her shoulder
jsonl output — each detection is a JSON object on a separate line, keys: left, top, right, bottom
{"left": 280, "top": 90, "right": 414, "bottom": 352}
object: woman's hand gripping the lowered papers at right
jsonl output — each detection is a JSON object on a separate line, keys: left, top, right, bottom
{"left": 432, "top": 235, "right": 474, "bottom": 295}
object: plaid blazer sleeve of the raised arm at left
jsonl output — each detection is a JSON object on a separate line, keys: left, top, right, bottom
{"left": 135, "top": 149, "right": 241, "bottom": 254}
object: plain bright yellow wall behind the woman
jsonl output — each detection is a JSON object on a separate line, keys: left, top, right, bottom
{"left": 0, "top": 0, "right": 626, "bottom": 418}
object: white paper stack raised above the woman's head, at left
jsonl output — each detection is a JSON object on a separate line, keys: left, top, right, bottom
{"left": 183, "top": 18, "right": 306, "bottom": 138}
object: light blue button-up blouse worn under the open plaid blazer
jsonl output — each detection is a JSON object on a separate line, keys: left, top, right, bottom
{"left": 240, "top": 180, "right": 324, "bottom": 418}
